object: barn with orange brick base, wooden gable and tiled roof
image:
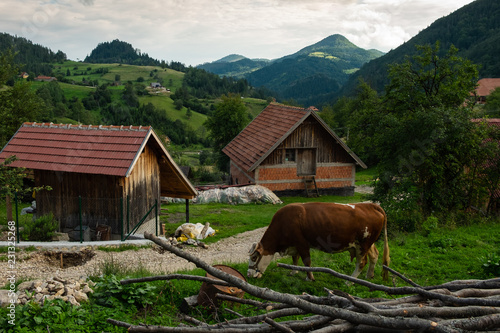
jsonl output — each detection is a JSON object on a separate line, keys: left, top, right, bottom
{"left": 223, "top": 103, "right": 366, "bottom": 195}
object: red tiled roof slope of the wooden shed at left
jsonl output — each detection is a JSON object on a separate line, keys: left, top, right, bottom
{"left": 0, "top": 123, "right": 152, "bottom": 177}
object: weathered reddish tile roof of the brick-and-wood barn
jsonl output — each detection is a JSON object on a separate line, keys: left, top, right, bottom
{"left": 222, "top": 103, "right": 366, "bottom": 171}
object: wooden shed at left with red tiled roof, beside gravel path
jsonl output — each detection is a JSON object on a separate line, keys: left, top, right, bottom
{"left": 0, "top": 123, "right": 197, "bottom": 239}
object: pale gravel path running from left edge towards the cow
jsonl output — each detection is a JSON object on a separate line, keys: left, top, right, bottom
{"left": 0, "top": 228, "right": 266, "bottom": 285}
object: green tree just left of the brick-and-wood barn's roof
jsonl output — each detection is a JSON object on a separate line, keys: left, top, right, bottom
{"left": 205, "top": 94, "right": 248, "bottom": 171}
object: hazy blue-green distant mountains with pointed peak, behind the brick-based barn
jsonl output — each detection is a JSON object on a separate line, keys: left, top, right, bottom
{"left": 197, "top": 34, "right": 384, "bottom": 106}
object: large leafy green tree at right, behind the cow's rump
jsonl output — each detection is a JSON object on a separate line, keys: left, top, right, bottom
{"left": 373, "top": 43, "right": 485, "bottom": 215}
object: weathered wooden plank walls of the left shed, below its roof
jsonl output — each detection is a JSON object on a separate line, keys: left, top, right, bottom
{"left": 35, "top": 146, "right": 160, "bottom": 234}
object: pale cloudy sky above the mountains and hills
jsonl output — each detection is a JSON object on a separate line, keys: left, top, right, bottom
{"left": 0, "top": 0, "right": 473, "bottom": 66}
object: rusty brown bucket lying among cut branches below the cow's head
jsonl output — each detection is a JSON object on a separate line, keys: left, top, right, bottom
{"left": 198, "top": 265, "right": 246, "bottom": 309}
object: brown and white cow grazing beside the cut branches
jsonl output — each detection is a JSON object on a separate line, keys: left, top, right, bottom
{"left": 247, "top": 202, "right": 390, "bottom": 280}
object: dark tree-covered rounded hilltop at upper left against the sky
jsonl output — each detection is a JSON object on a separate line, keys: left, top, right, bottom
{"left": 84, "top": 39, "right": 160, "bottom": 66}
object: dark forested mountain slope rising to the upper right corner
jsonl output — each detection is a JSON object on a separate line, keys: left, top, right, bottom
{"left": 338, "top": 0, "right": 500, "bottom": 96}
